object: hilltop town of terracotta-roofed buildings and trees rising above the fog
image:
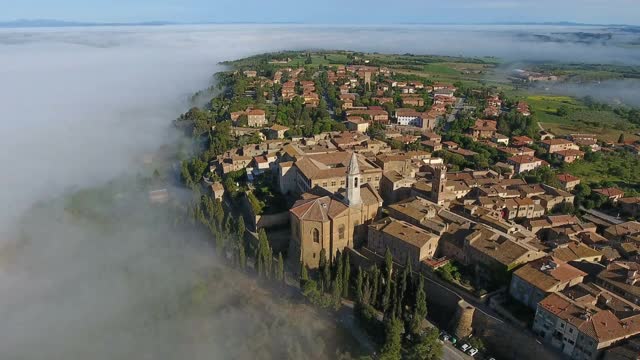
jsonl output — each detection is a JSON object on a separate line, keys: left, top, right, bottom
{"left": 172, "top": 51, "right": 640, "bottom": 359}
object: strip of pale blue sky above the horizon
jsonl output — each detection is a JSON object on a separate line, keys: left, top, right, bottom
{"left": 0, "top": 0, "right": 640, "bottom": 25}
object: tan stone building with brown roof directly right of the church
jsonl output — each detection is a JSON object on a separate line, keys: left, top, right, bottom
{"left": 367, "top": 218, "right": 439, "bottom": 269}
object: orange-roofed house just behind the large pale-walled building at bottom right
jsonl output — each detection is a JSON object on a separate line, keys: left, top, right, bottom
{"left": 509, "top": 257, "right": 587, "bottom": 310}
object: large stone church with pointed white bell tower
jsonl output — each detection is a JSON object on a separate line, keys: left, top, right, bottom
{"left": 289, "top": 153, "right": 382, "bottom": 269}
